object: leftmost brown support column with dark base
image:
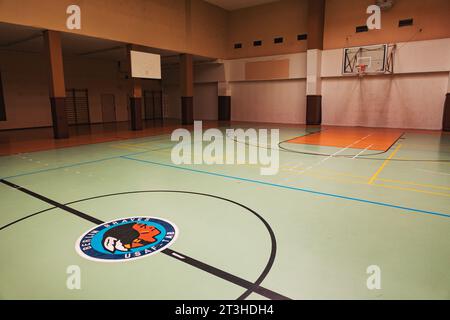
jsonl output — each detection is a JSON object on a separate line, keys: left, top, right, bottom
{"left": 44, "top": 30, "right": 69, "bottom": 139}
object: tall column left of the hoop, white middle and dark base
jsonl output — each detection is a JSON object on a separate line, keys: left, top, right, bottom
{"left": 306, "top": 0, "right": 325, "bottom": 125}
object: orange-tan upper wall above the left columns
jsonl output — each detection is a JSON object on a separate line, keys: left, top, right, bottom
{"left": 0, "top": 0, "right": 227, "bottom": 57}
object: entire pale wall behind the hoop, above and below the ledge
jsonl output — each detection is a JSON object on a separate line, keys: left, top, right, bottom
{"left": 322, "top": 39, "right": 450, "bottom": 130}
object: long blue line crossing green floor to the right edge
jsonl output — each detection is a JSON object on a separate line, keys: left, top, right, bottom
{"left": 121, "top": 156, "right": 450, "bottom": 218}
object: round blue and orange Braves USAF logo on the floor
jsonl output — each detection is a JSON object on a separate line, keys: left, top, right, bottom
{"left": 75, "top": 217, "right": 178, "bottom": 262}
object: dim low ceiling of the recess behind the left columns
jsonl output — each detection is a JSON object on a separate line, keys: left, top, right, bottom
{"left": 0, "top": 23, "right": 211, "bottom": 63}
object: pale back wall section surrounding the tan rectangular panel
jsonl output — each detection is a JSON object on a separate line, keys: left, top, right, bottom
{"left": 225, "top": 52, "right": 306, "bottom": 124}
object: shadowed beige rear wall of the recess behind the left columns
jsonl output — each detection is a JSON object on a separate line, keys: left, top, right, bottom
{"left": 0, "top": 51, "right": 160, "bottom": 130}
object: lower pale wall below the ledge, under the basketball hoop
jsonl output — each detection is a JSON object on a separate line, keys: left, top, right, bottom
{"left": 322, "top": 73, "right": 448, "bottom": 130}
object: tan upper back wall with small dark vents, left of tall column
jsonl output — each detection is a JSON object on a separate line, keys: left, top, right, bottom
{"left": 227, "top": 0, "right": 307, "bottom": 59}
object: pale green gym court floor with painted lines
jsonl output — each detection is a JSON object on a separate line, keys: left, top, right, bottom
{"left": 0, "top": 128, "right": 450, "bottom": 299}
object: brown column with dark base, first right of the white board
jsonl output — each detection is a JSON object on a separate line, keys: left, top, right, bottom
{"left": 180, "top": 54, "right": 194, "bottom": 125}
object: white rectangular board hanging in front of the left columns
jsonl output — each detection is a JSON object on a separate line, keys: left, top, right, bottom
{"left": 130, "top": 51, "right": 161, "bottom": 79}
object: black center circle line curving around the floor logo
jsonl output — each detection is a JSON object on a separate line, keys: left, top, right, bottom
{"left": 0, "top": 190, "right": 277, "bottom": 300}
